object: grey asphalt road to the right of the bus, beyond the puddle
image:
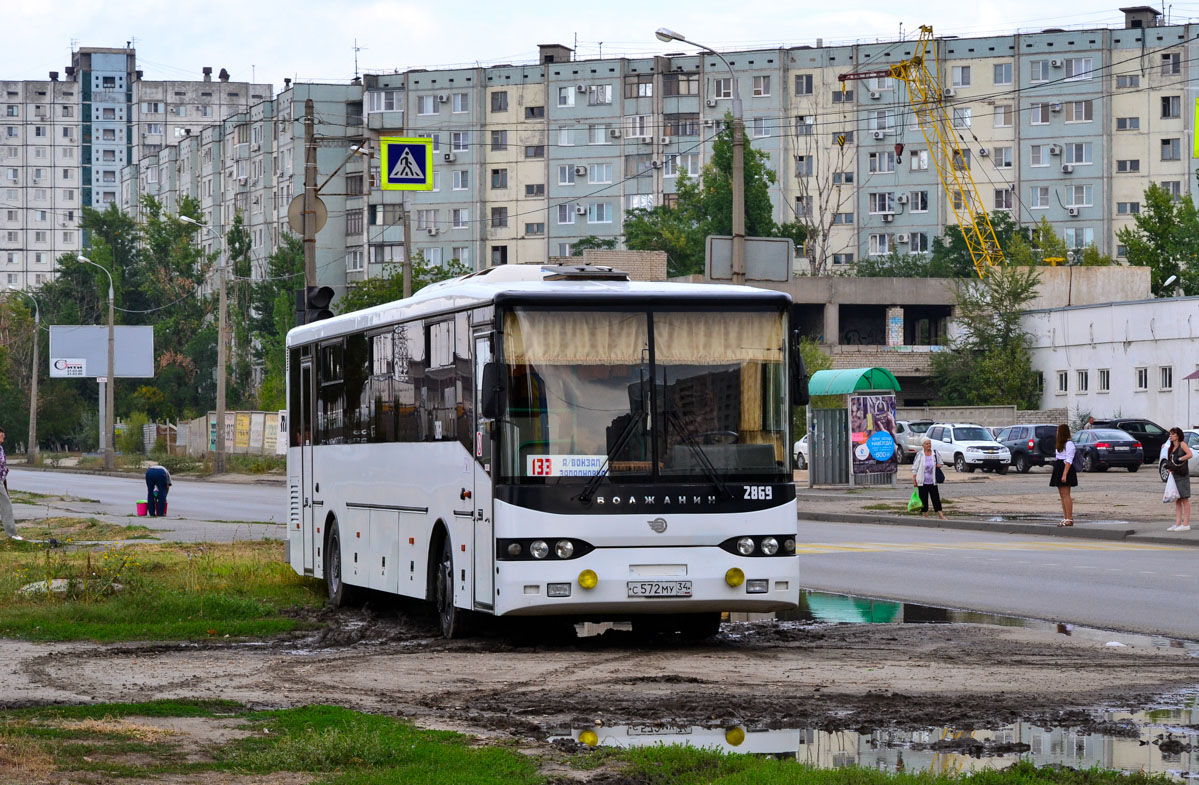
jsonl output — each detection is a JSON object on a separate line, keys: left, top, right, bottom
{"left": 797, "top": 520, "right": 1199, "bottom": 640}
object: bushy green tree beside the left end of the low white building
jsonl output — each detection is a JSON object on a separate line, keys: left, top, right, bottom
{"left": 932, "top": 265, "right": 1040, "bottom": 409}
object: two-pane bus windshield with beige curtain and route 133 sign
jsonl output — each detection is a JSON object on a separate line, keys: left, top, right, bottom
{"left": 496, "top": 308, "right": 788, "bottom": 484}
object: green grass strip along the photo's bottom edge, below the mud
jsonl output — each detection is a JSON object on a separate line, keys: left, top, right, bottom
{"left": 0, "top": 700, "right": 1173, "bottom": 785}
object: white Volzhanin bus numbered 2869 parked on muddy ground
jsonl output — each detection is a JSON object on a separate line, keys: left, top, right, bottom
{"left": 287, "top": 265, "right": 807, "bottom": 638}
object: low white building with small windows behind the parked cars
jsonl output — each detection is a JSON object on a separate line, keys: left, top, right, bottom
{"left": 1024, "top": 297, "right": 1199, "bottom": 428}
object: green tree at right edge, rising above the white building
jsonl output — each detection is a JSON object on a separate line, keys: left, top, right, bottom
{"left": 1116, "top": 183, "right": 1199, "bottom": 297}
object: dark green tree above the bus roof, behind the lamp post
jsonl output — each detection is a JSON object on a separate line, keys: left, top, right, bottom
{"left": 625, "top": 114, "right": 806, "bottom": 277}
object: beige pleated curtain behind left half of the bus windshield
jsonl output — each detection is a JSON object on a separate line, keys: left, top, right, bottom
{"left": 504, "top": 310, "right": 650, "bottom": 366}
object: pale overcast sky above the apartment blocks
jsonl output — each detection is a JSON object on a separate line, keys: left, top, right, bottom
{"left": 0, "top": 0, "right": 1199, "bottom": 91}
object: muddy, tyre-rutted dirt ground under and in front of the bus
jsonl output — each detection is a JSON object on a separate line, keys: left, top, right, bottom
{"left": 0, "top": 609, "right": 1199, "bottom": 736}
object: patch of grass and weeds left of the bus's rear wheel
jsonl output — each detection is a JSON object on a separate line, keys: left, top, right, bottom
{"left": 0, "top": 541, "right": 324, "bottom": 642}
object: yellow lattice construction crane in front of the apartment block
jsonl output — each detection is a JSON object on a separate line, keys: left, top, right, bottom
{"left": 838, "top": 25, "right": 1004, "bottom": 278}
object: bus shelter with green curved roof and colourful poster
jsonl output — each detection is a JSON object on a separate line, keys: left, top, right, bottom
{"left": 807, "top": 368, "right": 900, "bottom": 488}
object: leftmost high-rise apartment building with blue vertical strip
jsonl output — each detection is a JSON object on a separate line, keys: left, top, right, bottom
{"left": 0, "top": 47, "right": 272, "bottom": 288}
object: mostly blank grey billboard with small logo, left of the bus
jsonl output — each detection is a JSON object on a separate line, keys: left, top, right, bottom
{"left": 50, "top": 325, "right": 153, "bottom": 379}
